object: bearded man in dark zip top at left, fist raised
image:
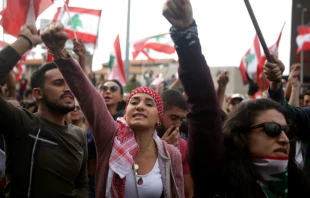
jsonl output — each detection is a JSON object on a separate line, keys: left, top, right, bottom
{"left": 0, "top": 25, "right": 88, "bottom": 198}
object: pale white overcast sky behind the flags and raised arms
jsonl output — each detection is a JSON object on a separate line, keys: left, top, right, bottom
{"left": 0, "top": 0, "right": 292, "bottom": 74}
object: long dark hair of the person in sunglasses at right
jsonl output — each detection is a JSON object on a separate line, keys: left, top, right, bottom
{"left": 223, "top": 99, "right": 310, "bottom": 198}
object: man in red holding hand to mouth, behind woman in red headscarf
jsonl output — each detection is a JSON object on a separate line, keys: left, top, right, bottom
{"left": 157, "top": 89, "right": 194, "bottom": 198}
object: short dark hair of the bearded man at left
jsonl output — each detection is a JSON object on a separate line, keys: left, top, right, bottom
{"left": 31, "top": 62, "right": 57, "bottom": 89}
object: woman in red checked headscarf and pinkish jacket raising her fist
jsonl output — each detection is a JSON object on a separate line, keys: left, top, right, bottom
{"left": 41, "top": 22, "right": 184, "bottom": 198}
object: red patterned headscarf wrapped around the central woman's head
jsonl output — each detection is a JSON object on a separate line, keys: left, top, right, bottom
{"left": 126, "top": 87, "right": 164, "bottom": 120}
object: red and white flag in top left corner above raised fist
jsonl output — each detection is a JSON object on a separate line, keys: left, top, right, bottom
{"left": 0, "top": 0, "right": 53, "bottom": 37}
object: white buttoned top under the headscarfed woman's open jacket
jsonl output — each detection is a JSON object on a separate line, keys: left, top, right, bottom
{"left": 125, "top": 159, "right": 163, "bottom": 198}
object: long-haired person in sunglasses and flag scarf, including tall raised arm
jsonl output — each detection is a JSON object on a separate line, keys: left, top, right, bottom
{"left": 163, "top": 0, "right": 310, "bottom": 198}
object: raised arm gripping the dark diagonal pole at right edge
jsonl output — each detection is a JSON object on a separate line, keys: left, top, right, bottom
{"left": 264, "top": 56, "right": 310, "bottom": 141}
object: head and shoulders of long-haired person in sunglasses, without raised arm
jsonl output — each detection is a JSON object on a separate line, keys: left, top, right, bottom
{"left": 218, "top": 99, "right": 310, "bottom": 198}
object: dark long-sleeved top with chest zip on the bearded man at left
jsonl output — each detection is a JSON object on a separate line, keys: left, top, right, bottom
{"left": 0, "top": 47, "right": 88, "bottom": 198}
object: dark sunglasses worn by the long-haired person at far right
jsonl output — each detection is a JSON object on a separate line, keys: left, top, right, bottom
{"left": 250, "top": 122, "right": 295, "bottom": 140}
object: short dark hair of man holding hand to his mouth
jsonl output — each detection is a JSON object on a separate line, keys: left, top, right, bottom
{"left": 161, "top": 89, "right": 188, "bottom": 111}
